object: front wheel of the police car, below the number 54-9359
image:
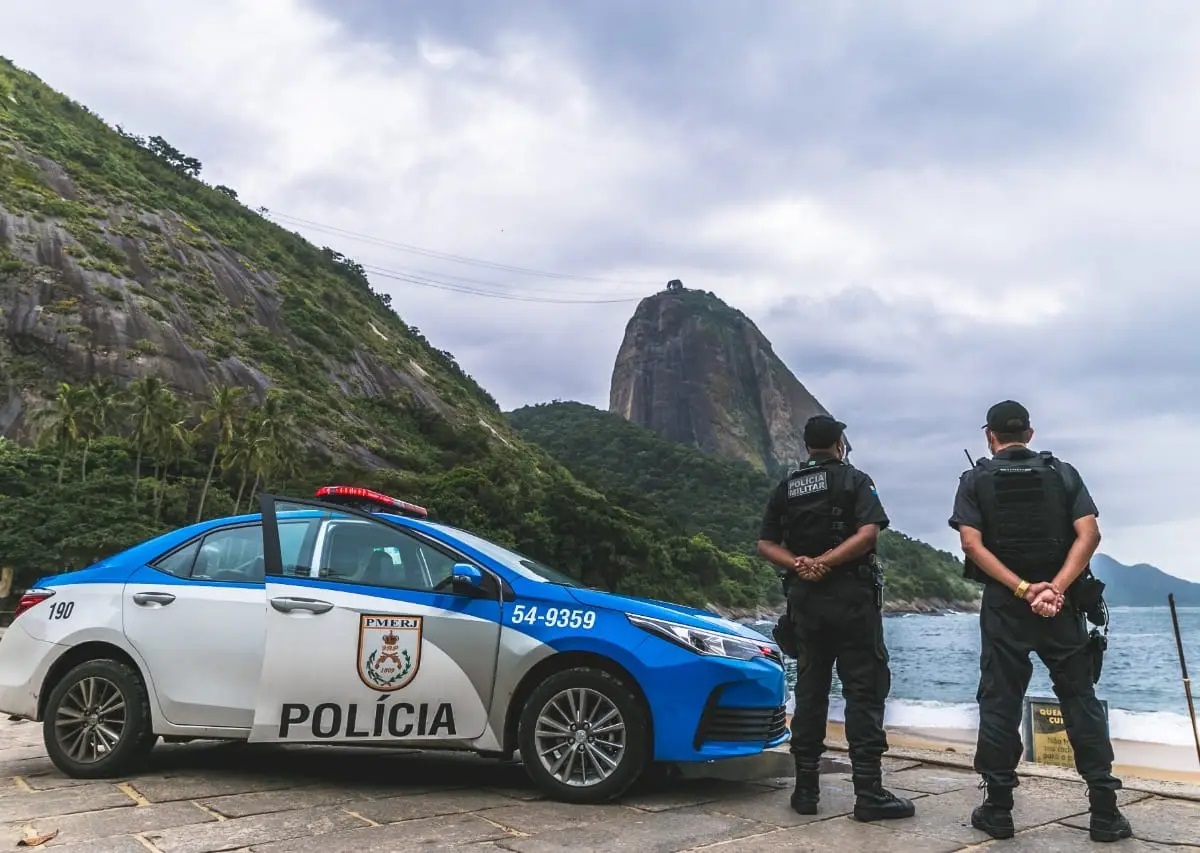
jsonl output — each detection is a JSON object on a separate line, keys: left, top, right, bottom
{"left": 517, "top": 667, "right": 650, "bottom": 804}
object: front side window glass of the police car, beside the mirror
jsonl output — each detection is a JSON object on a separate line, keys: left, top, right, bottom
{"left": 320, "top": 519, "right": 472, "bottom": 593}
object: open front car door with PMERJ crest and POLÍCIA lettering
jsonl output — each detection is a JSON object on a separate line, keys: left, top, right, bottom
{"left": 250, "top": 495, "right": 500, "bottom": 743}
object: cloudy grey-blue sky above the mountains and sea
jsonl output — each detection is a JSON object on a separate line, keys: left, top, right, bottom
{"left": 7, "top": 0, "right": 1200, "bottom": 579}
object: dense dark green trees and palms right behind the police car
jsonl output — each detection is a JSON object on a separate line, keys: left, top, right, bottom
{"left": 0, "top": 376, "right": 773, "bottom": 606}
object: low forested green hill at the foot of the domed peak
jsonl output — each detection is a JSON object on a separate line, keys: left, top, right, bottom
{"left": 508, "top": 402, "right": 978, "bottom": 601}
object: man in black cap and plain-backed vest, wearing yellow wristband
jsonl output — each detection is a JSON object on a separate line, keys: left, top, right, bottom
{"left": 949, "top": 400, "right": 1132, "bottom": 841}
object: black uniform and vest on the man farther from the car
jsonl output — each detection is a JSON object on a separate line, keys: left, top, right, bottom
{"left": 949, "top": 446, "right": 1121, "bottom": 810}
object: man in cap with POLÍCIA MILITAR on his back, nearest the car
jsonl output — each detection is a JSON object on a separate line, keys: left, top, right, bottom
{"left": 758, "top": 415, "right": 916, "bottom": 821}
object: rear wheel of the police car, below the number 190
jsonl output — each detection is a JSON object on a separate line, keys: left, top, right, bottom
{"left": 42, "top": 659, "right": 158, "bottom": 779}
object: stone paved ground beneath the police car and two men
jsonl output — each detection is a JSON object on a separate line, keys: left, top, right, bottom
{"left": 0, "top": 720, "right": 1200, "bottom": 853}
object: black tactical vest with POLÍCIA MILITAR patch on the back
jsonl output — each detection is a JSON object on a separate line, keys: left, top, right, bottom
{"left": 784, "top": 459, "right": 854, "bottom": 557}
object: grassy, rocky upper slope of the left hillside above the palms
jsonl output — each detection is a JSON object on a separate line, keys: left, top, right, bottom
{"left": 0, "top": 60, "right": 504, "bottom": 464}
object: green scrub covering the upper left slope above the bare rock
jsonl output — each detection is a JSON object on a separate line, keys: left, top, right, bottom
{"left": 0, "top": 59, "right": 497, "bottom": 434}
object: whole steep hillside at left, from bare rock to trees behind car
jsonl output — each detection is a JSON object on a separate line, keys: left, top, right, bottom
{"left": 0, "top": 60, "right": 769, "bottom": 614}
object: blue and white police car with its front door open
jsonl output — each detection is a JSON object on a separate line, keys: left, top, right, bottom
{"left": 0, "top": 486, "right": 787, "bottom": 803}
